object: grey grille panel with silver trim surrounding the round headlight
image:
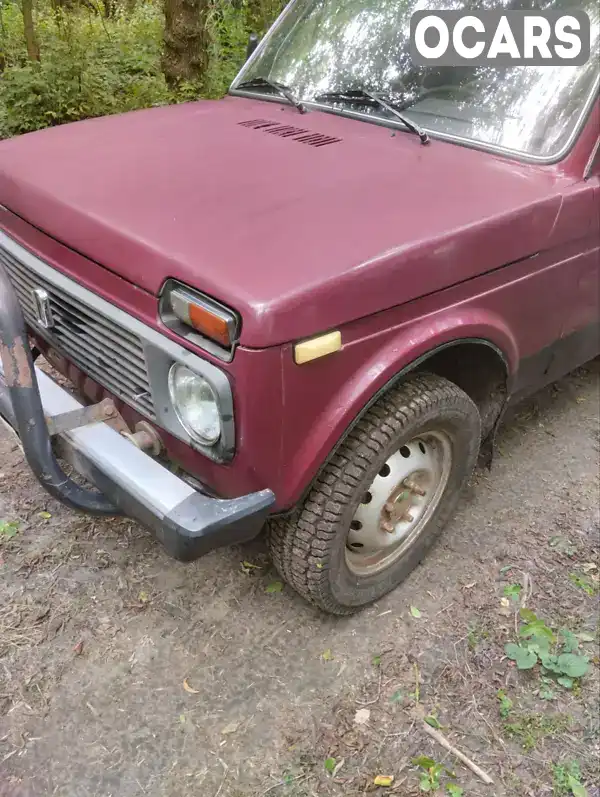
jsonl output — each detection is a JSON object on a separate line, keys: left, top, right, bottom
{"left": 0, "top": 229, "right": 236, "bottom": 462}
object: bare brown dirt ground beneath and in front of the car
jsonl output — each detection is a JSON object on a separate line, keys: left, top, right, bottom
{"left": 0, "top": 360, "right": 600, "bottom": 797}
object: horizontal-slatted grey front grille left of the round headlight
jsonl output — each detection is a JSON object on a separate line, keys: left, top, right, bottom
{"left": 0, "top": 248, "right": 155, "bottom": 419}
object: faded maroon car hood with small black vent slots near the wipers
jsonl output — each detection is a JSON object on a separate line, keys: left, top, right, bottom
{"left": 0, "top": 97, "right": 561, "bottom": 347}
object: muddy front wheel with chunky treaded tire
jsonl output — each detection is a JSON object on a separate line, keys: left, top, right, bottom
{"left": 268, "top": 374, "right": 481, "bottom": 615}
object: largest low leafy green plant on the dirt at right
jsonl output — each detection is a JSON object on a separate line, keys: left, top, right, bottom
{"left": 504, "top": 609, "right": 589, "bottom": 689}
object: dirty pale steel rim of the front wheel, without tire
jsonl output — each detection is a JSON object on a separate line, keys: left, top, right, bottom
{"left": 346, "top": 430, "right": 452, "bottom": 577}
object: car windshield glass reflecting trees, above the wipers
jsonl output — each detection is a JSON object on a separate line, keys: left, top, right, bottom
{"left": 232, "top": 0, "right": 600, "bottom": 159}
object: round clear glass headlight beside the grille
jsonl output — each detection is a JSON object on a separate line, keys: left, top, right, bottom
{"left": 169, "top": 363, "right": 221, "bottom": 446}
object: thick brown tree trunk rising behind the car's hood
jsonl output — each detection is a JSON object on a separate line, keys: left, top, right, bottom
{"left": 162, "top": 0, "right": 210, "bottom": 87}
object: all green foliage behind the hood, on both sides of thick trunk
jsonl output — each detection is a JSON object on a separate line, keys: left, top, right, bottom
{"left": 0, "top": 0, "right": 280, "bottom": 138}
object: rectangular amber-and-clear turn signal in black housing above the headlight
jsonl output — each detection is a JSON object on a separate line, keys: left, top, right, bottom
{"left": 161, "top": 283, "right": 239, "bottom": 349}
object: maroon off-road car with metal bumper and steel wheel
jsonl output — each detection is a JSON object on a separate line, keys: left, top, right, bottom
{"left": 0, "top": 0, "right": 600, "bottom": 614}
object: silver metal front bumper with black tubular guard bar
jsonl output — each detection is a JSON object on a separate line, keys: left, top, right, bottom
{"left": 0, "top": 266, "right": 275, "bottom": 561}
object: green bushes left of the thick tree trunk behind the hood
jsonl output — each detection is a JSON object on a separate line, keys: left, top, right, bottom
{"left": 0, "top": 4, "right": 166, "bottom": 136}
